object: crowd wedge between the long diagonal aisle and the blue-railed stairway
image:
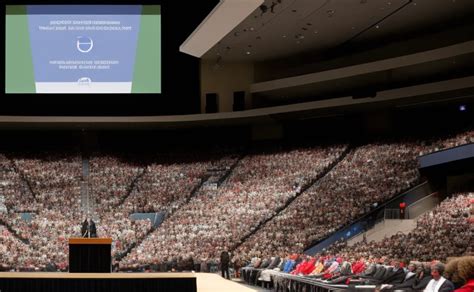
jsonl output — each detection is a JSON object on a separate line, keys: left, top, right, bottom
{"left": 234, "top": 142, "right": 426, "bottom": 259}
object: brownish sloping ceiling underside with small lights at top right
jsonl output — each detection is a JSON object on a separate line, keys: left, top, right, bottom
{"left": 203, "top": 0, "right": 474, "bottom": 62}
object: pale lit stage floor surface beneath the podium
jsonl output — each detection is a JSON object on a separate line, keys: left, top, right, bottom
{"left": 0, "top": 272, "right": 268, "bottom": 292}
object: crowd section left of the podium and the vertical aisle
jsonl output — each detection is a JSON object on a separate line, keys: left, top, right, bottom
{"left": 2, "top": 153, "right": 81, "bottom": 270}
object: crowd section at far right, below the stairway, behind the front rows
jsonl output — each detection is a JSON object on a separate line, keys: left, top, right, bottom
{"left": 329, "top": 193, "right": 474, "bottom": 261}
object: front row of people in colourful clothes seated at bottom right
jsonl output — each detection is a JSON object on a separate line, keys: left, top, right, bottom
{"left": 241, "top": 254, "right": 474, "bottom": 292}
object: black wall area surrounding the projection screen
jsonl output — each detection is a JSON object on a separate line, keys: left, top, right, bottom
{"left": 0, "top": 0, "right": 218, "bottom": 116}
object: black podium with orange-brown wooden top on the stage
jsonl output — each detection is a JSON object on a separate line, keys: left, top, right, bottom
{"left": 69, "top": 238, "right": 112, "bottom": 273}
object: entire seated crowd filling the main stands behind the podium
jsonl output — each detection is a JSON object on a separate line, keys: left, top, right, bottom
{"left": 0, "top": 131, "right": 473, "bottom": 269}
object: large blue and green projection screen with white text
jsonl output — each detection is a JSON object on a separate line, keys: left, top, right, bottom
{"left": 5, "top": 5, "right": 162, "bottom": 94}
